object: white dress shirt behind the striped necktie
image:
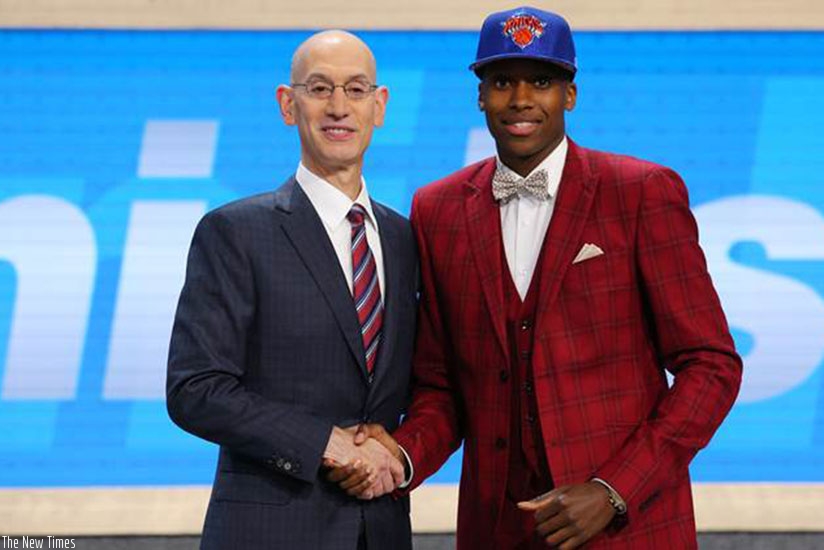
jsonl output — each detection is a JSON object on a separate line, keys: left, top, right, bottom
{"left": 295, "top": 162, "right": 386, "bottom": 303}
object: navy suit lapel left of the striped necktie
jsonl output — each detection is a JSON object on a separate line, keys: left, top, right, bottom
{"left": 275, "top": 178, "right": 366, "bottom": 378}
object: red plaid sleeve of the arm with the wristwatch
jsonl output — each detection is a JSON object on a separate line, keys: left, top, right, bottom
{"left": 595, "top": 169, "right": 742, "bottom": 521}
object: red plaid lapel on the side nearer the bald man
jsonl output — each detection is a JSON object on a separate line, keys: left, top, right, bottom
{"left": 464, "top": 159, "right": 509, "bottom": 357}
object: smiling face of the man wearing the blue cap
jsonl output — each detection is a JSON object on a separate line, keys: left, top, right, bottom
{"left": 478, "top": 59, "right": 577, "bottom": 176}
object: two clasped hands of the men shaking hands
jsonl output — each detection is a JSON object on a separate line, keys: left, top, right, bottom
{"left": 323, "top": 424, "right": 406, "bottom": 500}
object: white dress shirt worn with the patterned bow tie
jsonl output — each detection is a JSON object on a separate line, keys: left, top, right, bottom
{"left": 498, "top": 136, "right": 568, "bottom": 300}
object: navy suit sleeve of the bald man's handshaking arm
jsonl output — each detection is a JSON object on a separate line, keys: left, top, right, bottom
{"left": 166, "top": 212, "right": 332, "bottom": 482}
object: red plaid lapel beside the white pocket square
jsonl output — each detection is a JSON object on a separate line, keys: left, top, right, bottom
{"left": 538, "top": 140, "right": 598, "bottom": 319}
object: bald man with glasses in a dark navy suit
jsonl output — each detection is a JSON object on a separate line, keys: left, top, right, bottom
{"left": 167, "top": 31, "right": 417, "bottom": 550}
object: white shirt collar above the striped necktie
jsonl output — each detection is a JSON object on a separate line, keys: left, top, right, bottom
{"left": 295, "top": 162, "right": 378, "bottom": 231}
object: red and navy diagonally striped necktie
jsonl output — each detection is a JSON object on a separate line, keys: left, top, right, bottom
{"left": 346, "top": 203, "right": 383, "bottom": 377}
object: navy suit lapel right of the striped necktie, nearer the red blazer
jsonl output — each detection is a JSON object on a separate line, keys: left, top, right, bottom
{"left": 371, "top": 201, "right": 402, "bottom": 391}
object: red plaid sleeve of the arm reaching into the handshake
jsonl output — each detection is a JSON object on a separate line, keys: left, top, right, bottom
{"left": 394, "top": 195, "right": 463, "bottom": 490}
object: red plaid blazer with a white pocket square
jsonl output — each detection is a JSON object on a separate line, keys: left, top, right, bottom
{"left": 395, "top": 142, "right": 741, "bottom": 549}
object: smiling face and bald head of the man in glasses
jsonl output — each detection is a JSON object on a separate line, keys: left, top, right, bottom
{"left": 277, "top": 31, "right": 387, "bottom": 177}
